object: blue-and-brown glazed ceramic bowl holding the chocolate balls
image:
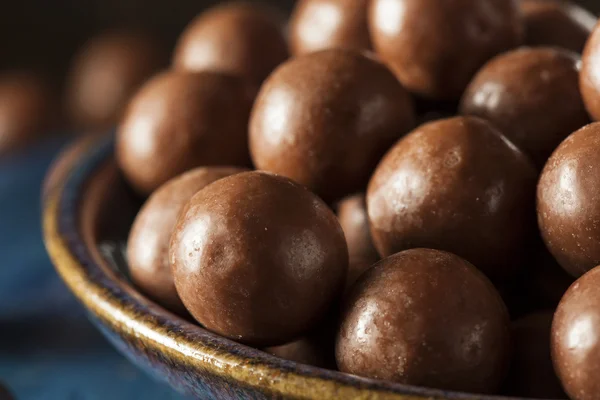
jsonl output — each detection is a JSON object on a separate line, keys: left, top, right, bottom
{"left": 43, "top": 135, "right": 524, "bottom": 400}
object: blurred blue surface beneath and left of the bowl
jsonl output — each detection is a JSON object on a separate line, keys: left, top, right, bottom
{"left": 0, "top": 139, "right": 190, "bottom": 400}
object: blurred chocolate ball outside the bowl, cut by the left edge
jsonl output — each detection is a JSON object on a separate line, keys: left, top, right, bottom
{"left": 0, "top": 72, "right": 58, "bottom": 156}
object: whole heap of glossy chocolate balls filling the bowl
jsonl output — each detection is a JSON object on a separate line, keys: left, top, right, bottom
{"left": 116, "top": 0, "right": 600, "bottom": 400}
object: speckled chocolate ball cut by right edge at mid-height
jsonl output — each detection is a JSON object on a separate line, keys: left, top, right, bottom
{"left": 537, "top": 122, "right": 600, "bottom": 277}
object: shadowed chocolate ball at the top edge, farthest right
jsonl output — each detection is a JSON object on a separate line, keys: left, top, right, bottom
{"left": 520, "top": 0, "right": 597, "bottom": 53}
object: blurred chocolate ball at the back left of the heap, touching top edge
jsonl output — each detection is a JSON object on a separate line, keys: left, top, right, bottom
{"left": 173, "top": 2, "right": 288, "bottom": 84}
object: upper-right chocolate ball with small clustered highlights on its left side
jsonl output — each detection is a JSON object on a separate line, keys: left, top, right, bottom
{"left": 460, "top": 48, "right": 589, "bottom": 169}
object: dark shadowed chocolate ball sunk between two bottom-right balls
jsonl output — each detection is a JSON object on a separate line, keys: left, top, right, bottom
{"left": 506, "top": 311, "right": 567, "bottom": 399}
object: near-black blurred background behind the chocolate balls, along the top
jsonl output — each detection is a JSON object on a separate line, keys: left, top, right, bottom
{"left": 0, "top": 0, "right": 600, "bottom": 84}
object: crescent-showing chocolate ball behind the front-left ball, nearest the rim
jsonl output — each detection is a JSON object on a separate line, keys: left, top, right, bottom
{"left": 127, "top": 167, "right": 245, "bottom": 312}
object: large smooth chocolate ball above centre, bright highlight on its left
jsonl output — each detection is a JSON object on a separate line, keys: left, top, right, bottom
{"left": 250, "top": 49, "right": 415, "bottom": 201}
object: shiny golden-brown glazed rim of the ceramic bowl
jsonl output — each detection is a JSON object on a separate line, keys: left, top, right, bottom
{"left": 42, "top": 134, "right": 517, "bottom": 400}
